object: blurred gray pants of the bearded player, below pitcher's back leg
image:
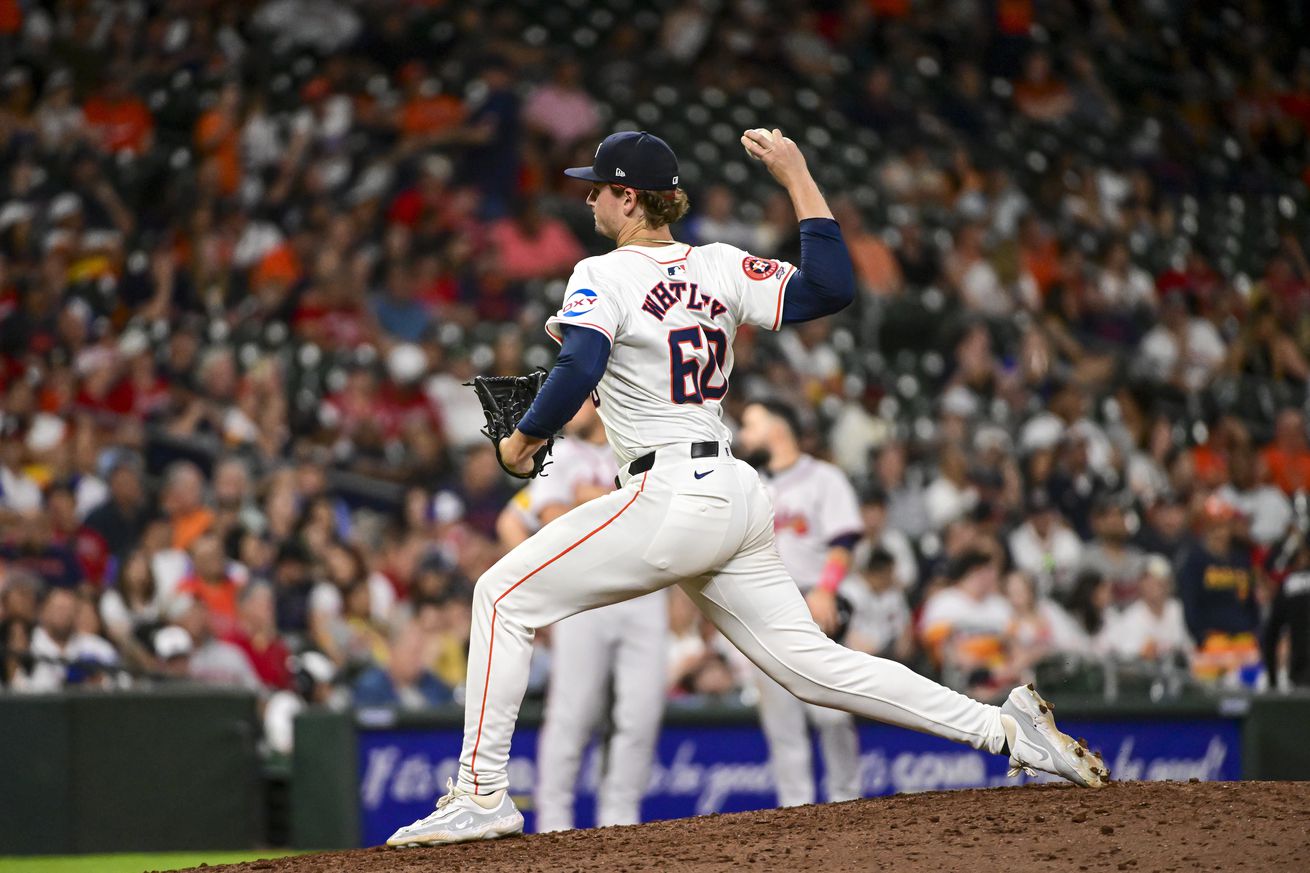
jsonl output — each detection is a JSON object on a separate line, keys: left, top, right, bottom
{"left": 756, "top": 672, "right": 861, "bottom": 806}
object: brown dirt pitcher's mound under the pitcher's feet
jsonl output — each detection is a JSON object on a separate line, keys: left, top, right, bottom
{"left": 184, "top": 783, "right": 1310, "bottom": 873}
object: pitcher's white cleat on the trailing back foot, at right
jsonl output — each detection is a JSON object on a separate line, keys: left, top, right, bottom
{"left": 1001, "top": 684, "right": 1110, "bottom": 788}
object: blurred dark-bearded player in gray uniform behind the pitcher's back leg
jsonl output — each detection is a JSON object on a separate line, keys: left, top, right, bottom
{"left": 738, "top": 400, "right": 862, "bottom": 806}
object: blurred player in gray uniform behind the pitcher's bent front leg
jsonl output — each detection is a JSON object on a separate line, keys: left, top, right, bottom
{"left": 496, "top": 402, "right": 668, "bottom": 832}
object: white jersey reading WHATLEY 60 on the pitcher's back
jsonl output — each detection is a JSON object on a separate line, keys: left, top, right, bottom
{"left": 546, "top": 243, "right": 796, "bottom": 464}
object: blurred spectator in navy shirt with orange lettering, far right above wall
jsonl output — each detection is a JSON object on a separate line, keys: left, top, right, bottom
{"left": 1175, "top": 497, "right": 1256, "bottom": 648}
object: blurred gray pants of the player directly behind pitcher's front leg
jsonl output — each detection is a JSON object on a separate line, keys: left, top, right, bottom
{"left": 536, "top": 591, "right": 668, "bottom": 832}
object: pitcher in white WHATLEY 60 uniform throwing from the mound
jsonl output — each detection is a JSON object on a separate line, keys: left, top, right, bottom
{"left": 388, "top": 130, "right": 1108, "bottom": 845}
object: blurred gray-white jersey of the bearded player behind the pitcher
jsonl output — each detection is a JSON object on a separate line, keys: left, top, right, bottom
{"left": 764, "top": 455, "right": 863, "bottom": 591}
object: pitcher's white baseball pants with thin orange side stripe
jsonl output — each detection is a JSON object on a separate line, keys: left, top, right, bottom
{"left": 460, "top": 444, "right": 1005, "bottom": 793}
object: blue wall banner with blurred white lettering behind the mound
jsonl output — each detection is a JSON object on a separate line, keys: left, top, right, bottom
{"left": 358, "top": 717, "right": 1242, "bottom": 845}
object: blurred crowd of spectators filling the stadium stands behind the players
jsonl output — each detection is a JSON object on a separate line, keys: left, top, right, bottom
{"left": 0, "top": 0, "right": 1310, "bottom": 744}
